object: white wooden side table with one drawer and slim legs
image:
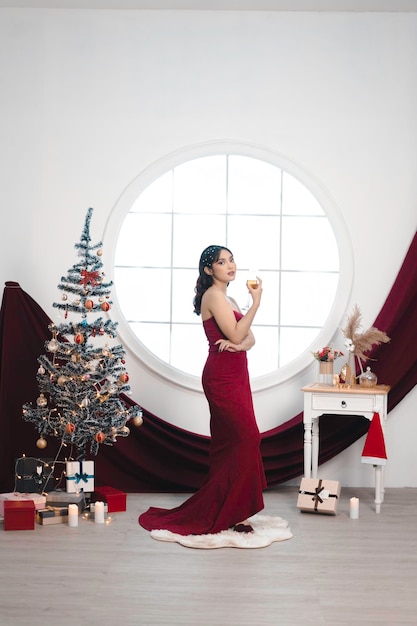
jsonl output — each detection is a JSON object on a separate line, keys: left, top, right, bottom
{"left": 301, "top": 383, "right": 390, "bottom": 513}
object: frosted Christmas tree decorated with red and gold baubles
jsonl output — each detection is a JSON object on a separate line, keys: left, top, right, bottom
{"left": 23, "top": 209, "right": 142, "bottom": 459}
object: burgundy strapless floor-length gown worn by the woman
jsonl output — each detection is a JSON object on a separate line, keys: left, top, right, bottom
{"left": 139, "top": 312, "right": 266, "bottom": 535}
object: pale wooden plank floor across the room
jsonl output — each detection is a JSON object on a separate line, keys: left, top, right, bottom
{"left": 0, "top": 487, "right": 417, "bottom": 626}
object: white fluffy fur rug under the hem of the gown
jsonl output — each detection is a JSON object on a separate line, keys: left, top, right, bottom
{"left": 151, "top": 515, "right": 293, "bottom": 550}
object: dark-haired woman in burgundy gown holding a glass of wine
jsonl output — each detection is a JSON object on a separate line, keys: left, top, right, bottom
{"left": 139, "top": 246, "right": 266, "bottom": 535}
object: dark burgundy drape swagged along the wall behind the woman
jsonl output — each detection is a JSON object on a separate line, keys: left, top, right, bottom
{"left": 0, "top": 233, "right": 417, "bottom": 492}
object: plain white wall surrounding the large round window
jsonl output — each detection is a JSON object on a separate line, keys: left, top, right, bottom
{"left": 0, "top": 9, "right": 417, "bottom": 487}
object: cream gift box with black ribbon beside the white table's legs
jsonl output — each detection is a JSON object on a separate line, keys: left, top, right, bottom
{"left": 297, "top": 478, "right": 340, "bottom": 515}
